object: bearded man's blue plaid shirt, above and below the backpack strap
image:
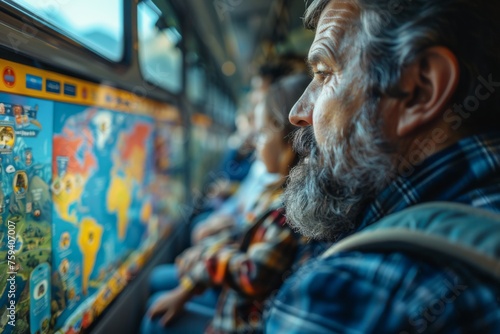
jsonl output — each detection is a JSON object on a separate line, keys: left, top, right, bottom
{"left": 266, "top": 134, "right": 500, "bottom": 334}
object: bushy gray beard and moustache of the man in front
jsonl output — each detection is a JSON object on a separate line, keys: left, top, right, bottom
{"left": 284, "top": 109, "right": 395, "bottom": 241}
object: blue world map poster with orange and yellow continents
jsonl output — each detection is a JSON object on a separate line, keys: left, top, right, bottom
{"left": 51, "top": 103, "right": 155, "bottom": 328}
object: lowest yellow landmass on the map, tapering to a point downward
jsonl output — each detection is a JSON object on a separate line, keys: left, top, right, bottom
{"left": 78, "top": 218, "right": 103, "bottom": 295}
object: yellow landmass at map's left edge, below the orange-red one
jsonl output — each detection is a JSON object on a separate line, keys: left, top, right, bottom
{"left": 53, "top": 174, "right": 84, "bottom": 225}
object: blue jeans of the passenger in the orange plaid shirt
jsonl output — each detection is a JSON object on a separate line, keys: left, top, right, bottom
{"left": 141, "top": 264, "right": 218, "bottom": 334}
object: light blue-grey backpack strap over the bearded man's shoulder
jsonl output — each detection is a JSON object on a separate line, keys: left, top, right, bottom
{"left": 322, "top": 202, "right": 500, "bottom": 280}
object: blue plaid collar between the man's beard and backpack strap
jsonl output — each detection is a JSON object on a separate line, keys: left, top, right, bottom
{"left": 356, "top": 133, "right": 500, "bottom": 231}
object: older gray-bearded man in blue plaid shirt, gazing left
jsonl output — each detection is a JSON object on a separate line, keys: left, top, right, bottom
{"left": 267, "top": 0, "right": 500, "bottom": 333}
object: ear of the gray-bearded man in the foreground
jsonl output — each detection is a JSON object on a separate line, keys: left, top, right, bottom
{"left": 397, "top": 47, "right": 460, "bottom": 137}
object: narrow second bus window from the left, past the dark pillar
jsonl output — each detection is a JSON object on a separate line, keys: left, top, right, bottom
{"left": 137, "top": 1, "right": 182, "bottom": 93}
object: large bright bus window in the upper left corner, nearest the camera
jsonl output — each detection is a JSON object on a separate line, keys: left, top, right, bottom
{"left": 12, "top": 0, "right": 124, "bottom": 62}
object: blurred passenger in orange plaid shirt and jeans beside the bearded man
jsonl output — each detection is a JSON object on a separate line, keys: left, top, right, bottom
{"left": 141, "top": 74, "right": 310, "bottom": 333}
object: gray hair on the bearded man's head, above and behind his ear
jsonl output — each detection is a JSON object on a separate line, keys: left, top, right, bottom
{"left": 304, "top": 0, "right": 500, "bottom": 127}
